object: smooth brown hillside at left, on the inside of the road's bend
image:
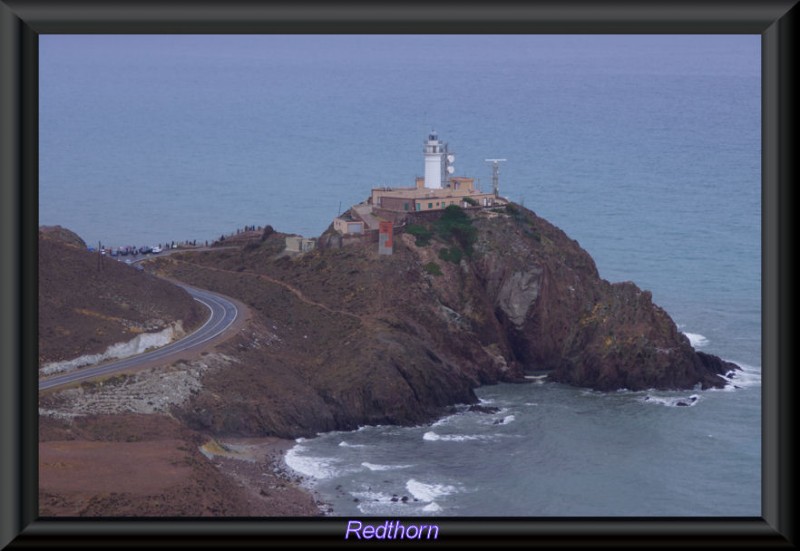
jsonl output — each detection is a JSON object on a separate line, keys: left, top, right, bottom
{"left": 39, "top": 226, "right": 206, "bottom": 365}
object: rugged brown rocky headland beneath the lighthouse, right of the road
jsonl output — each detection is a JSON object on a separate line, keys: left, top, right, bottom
{"left": 150, "top": 204, "right": 736, "bottom": 437}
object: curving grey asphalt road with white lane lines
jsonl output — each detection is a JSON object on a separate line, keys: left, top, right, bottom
{"left": 39, "top": 281, "right": 241, "bottom": 391}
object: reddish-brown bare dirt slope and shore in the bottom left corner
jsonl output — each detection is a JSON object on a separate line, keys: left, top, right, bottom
{"left": 39, "top": 414, "right": 320, "bottom": 517}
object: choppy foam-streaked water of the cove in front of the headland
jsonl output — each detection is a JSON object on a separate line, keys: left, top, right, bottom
{"left": 286, "top": 374, "right": 760, "bottom": 518}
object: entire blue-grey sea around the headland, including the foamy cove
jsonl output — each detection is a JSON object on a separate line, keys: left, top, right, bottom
{"left": 39, "top": 35, "right": 761, "bottom": 516}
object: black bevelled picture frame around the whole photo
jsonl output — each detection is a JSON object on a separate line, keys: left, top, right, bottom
{"left": 0, "top": 0, "right": 798, "bottom": 548}
